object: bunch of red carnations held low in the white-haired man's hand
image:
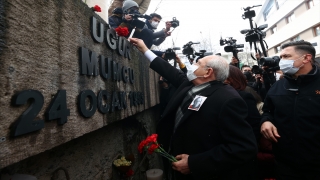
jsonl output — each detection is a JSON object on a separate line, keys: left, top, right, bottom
{"left": 138, "top": 134, "right": 177, "bottom": 162}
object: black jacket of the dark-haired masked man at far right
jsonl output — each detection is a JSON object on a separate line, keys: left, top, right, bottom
{"left": 261, "top": 66, "right": 320, "bottom": 169}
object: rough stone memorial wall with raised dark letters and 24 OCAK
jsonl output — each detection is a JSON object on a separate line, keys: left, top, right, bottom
{"left": 0, "top": 0, "right": 159, "bottom": 179}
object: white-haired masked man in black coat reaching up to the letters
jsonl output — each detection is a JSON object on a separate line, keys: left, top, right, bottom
{"left": 129, "top": 38, "right": 257, "bottom": 180}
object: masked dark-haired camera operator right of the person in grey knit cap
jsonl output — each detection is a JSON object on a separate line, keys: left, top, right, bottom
{"left": 146, "top": 13, "right": 171, "bottom": 46}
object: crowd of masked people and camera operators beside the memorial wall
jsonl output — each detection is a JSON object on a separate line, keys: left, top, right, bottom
{"left": 104, "top": 0, "right": 320, "bottom": 180}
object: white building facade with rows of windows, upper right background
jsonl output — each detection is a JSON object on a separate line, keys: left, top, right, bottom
{"left": 254, "top": 0, "right": 320, "bottom": 59}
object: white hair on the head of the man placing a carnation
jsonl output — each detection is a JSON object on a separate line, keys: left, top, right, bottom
{"left": 207, "top": 56, "right": 229, "bottom": 82}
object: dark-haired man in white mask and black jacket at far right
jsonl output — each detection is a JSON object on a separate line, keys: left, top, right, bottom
{"left": 261, "top": 41, "right": 320, "bottom": 180}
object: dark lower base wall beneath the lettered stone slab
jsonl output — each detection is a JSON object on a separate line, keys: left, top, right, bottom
{"left": 2, "top": 108, "right": 162, "bottom": 180}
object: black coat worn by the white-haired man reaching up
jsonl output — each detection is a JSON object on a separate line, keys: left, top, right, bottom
{"left": 150, "top": 57, "right": 257, "bottom": 180}
